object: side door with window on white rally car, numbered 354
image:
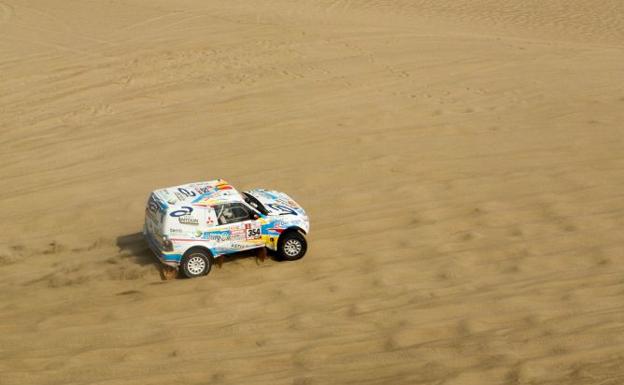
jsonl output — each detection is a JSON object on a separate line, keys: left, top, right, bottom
{"left": 214, "top": 203, "right": 262, "bottom": 253}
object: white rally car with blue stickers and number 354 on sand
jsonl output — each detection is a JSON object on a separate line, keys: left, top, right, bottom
{"left": 143, "top": 179, "right": 310, "bottom": 278}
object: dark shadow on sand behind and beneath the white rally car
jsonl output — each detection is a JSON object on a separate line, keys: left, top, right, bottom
{"left": 116, "top": 232, "right": 275, "bottom": 280}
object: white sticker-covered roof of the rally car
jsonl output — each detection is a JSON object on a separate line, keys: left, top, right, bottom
{"left": 153, "top": 179, "right": 243, "bottom": 207}
